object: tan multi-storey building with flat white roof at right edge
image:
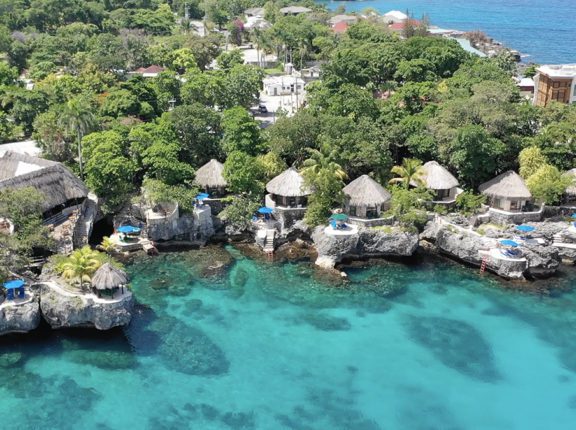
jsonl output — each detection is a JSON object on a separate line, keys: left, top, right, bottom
{"left": 533, "top": 64, "right": 576, "bottom": 106}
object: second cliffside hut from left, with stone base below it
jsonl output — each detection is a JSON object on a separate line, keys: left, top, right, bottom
{"left": 266, "top": 167, "right": 312, "bottom": 228}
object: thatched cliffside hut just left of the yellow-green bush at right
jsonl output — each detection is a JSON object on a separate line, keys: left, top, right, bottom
{"left": 478, "top": 170, "right": 532, "bottom": 212}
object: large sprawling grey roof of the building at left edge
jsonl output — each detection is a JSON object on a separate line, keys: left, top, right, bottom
{"left": 0, "top": 151, "right": 88, "bottom": 212}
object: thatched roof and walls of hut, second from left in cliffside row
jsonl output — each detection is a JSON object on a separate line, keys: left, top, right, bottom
{"left": 266, "top": 167, "right": 312, "bottom": 208}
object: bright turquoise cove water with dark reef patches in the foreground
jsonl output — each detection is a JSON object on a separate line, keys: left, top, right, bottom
{"left": 0, "top": 245, "right": 576, "bottom": 430}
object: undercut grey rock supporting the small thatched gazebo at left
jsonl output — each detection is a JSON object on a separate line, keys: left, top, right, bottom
{"left": 40, "top": 283, "right": 134, "bottom": 330}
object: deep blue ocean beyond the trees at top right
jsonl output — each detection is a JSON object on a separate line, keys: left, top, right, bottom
{"left": 318, "top": 0, "right": 576, "bottom": 64}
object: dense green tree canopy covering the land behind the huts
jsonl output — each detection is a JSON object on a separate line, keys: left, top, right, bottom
{"left": 0, "top": 0, "right": 576, "bottom": 224}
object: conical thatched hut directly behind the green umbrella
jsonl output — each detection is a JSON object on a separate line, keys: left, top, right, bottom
{"left": 342, "top": 175, "right": 392, "bottom": 219}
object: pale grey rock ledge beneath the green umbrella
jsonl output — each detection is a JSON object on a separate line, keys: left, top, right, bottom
{"left": 312, "top": 227, "right": 418, "bottom": 268}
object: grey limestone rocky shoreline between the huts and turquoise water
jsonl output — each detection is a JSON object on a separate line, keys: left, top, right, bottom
{"left": 0, "top": 215, "right": 576, "bottom": 335}
